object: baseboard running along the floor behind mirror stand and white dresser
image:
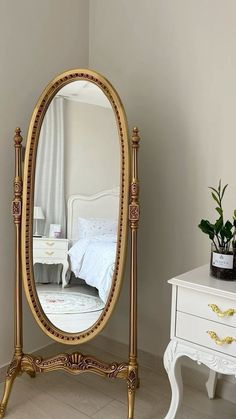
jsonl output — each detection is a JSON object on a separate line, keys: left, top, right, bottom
{"left": 0, "top": 335, "right": 236, "bottom": 403}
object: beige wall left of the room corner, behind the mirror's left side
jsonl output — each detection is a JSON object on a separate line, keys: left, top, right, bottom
{"left": 0, "top": 0, "right": 88, "bottom": 366}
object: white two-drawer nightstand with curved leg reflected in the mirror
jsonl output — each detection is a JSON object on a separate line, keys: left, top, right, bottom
{"left": 33, "top": 237, "right": 69, "bottom": 288}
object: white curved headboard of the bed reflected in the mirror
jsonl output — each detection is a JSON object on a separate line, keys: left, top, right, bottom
{"left": 67, "top": 188, "right": 119, "bottom": 241}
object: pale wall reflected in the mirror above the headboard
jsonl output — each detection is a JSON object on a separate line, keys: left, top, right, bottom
{"left": 64, "top": 100, "right": 120, "bottom": 200}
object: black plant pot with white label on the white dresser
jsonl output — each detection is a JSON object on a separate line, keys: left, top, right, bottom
{"left": 210, "top": 246, "right": 236, "bottom": 281}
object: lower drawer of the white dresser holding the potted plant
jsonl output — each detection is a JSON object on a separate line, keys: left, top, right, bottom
{"left": 176, "top": 312, "right": 236, "bottom": 357}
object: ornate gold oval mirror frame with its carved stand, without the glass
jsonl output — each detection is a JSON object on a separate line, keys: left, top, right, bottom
{"left": 0, "top": 69, "right": 140, "bottom": 419}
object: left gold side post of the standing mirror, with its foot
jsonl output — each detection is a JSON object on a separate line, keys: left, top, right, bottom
{"left": 0, "top": 128, "right": 23, "bottom": 418}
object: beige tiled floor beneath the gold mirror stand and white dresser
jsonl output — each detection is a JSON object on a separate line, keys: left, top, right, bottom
{"left": 0, "top": 344, "right": 236, "bottom": 419}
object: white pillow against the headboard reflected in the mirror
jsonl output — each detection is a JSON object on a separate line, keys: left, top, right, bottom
{"left": 78, "top": 217, "right": 118, "bottom": 239}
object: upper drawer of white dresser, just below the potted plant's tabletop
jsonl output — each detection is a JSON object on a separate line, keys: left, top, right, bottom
{"left": 177, "top": 287, "right": 236, "bottom": 327}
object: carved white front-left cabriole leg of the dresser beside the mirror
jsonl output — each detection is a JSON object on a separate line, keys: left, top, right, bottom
{"left": 164, "top": 342, "right": 183, "bottom": 419}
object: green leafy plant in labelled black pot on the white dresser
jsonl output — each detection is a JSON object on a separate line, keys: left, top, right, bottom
{"left": 198, "top": 181, "right": 236, "bottom": 280}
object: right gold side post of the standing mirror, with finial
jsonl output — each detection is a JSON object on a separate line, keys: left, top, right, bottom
{"left": 127, "top": 127, "right": 140, "bottom": 419}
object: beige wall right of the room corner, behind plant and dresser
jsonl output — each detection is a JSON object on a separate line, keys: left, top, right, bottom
{"left": 89, "top": 0, "right": 236, "bottom": 354}
